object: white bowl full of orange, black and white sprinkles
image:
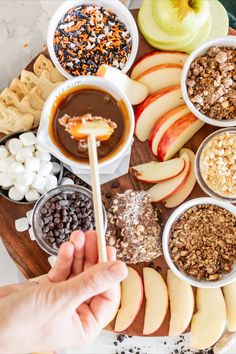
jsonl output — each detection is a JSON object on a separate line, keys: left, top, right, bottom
{"left": 47, "top": 0, "right": 138, "bottom": 79}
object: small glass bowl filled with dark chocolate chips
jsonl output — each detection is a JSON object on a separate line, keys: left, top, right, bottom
{"left": 32, "top": 185, "right": 107, "bottom": 255}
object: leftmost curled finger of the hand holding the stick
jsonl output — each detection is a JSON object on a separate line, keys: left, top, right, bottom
{"left": 48, "top": 241, "right": 75, "bottom": 283}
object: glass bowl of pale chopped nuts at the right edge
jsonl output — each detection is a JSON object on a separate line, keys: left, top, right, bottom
{"left": 195, "top": 128, "right": 236, "bottom": 203}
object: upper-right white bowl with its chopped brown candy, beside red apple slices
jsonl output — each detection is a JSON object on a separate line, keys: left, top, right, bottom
{"left": 181, "top": 36, "right": 236, "bottom": 127}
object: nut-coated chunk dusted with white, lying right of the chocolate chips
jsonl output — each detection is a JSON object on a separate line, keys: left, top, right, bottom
{"left": 106, "top": 190, "right": 162, "bottom": 264}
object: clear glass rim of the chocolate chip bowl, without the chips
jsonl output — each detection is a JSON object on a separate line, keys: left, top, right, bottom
{"left": 32, "top": 185, "right": 107, "bottom": 256}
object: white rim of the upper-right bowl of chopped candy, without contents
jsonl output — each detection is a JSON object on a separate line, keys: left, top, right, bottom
{"left": 181, "top": 36, "right": 236, "bottom": 128}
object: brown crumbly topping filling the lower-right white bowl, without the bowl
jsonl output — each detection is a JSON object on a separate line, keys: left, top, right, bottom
{"left": 169, "top": 204, "right": 236, "bottom": 281}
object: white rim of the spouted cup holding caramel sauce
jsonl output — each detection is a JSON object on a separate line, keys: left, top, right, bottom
{"left": 37, "top": 76, "right": 134, "bottom": 171}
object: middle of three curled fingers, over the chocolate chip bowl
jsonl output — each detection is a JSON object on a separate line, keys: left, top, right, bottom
{"left": 70, "top": 230, "right": 85, "bottom": 275}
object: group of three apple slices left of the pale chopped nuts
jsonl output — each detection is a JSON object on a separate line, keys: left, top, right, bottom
{"left": 130, "top": 149, "right": 196, "bottom": 208}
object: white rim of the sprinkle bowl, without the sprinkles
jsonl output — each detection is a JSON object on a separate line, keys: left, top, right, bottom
{"left": 47, "top": 0, "right": 139, "bottom": 79}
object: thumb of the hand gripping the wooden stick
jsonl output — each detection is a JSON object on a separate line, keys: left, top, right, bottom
{"left": 61, "top": 261, "right": 128, "bottom": 307}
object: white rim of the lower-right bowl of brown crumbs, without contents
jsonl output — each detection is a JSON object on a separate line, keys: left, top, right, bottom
{"left": 162, "top": 197, "right": 236, "bottom": 288}
